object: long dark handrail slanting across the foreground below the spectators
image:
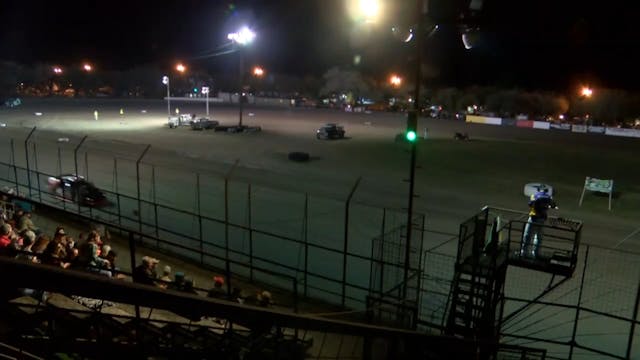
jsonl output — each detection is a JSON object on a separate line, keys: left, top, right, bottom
{"left": 0, "top": 257, "right": 473, "bottom": 347}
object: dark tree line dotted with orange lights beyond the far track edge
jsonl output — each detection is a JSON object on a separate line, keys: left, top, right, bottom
{"left": 0, "top": 61, "right": 640, "bottom": 125}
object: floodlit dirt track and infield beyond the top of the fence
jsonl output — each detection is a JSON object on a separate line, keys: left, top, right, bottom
{"left": 0, "top": 99, "right": 640, "bottom": 251}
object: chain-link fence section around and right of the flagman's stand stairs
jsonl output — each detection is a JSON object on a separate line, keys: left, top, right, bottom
{"left": 418, "top": 207, "right": 640, "bottom": 359}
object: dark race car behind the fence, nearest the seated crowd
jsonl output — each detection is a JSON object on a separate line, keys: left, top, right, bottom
{"left": 47, "top": 174, "right": 109, "bottom": 207}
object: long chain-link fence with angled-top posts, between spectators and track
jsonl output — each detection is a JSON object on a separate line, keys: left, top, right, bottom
{"left": 0, "top": 128, "right": 416, "bottom": 309}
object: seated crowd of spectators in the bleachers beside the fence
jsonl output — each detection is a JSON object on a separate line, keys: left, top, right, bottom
{"left": 0, "top": 202, "right": 273, "bottom": 317}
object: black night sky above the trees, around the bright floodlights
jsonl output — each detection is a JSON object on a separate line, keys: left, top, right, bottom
{"left": 0, "top": 0, "right": 640, "bottom": 90}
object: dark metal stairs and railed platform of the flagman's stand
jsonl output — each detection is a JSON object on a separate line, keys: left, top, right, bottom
{"left": 443, "top": 207, "right": 582, "bottom": 359}
